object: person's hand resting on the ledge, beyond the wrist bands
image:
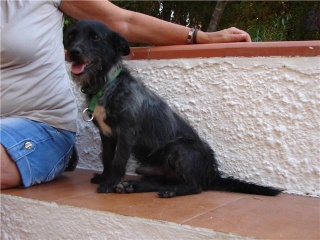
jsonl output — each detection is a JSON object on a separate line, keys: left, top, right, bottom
{"left": 197, "top": 27, "right": 251, "bottom": 44}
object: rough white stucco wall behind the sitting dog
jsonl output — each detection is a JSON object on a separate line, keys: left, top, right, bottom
{"left": 70, "top": 57, "right": 320, "bottom": 196}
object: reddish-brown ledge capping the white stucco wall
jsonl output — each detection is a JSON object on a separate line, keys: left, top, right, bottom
{"left": 126, "top": 41, "right": 320, "bottom": 60}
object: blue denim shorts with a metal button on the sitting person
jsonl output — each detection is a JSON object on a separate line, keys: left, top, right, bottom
{"left": 0, "top": 118, "right": 76, "bottom": 187}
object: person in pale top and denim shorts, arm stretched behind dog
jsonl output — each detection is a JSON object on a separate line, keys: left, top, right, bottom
{"left": 0, "top": 0, "right": 251, "bottom": 189}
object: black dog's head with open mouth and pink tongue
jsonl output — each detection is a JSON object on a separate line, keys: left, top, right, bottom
{"left": 63, "top": 20, "right": 130, "bottom": 86}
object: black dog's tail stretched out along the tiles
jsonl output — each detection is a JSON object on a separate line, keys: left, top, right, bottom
{"left": 211, "top": 177, "right": 282, "bottom": 196}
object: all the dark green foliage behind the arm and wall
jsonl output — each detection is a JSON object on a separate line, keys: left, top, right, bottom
{"left": 65, "top": 0, "right": 320, "bottom": 41}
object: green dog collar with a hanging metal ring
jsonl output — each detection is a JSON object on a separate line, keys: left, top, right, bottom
{"left": 82, "top": 64, "right": 122, "bottom": 122}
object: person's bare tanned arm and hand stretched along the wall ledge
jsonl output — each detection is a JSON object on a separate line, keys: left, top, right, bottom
{"left": 60, "top": 0, "right": 251, "bottom": 45}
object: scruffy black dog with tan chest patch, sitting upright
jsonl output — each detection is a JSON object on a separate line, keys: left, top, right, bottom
{"left": 64, "top": 20, "right": 281, "bottom": 197}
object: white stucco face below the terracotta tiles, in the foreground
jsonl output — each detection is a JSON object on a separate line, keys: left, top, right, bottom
{"left": 0, "top": 194, "right": 253, "bottom": 240}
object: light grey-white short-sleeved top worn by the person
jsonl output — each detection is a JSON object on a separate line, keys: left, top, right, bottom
{"left": 0, "top": 0, "right": 77, "bottom": 132}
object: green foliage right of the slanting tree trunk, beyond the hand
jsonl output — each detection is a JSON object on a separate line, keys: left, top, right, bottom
{"left": 219, "top": 1, "right": 320, "bottom": 41}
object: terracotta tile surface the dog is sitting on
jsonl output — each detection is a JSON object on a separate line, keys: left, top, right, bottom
{"left": 2, "top": 169, "right": 320, "bottom": 240}
